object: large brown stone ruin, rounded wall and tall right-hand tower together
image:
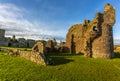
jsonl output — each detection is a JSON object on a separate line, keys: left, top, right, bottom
{"left": 66, "top": 4, "right": 115, "bottom": 58}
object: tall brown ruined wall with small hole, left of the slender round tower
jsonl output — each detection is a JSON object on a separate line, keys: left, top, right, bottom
{"left": 66, "top": 13, "right": 102, "bottom": 56}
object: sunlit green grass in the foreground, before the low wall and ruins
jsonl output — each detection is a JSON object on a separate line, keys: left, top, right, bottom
{"left": 0, "top": 52, "right": 120, "bottom": 81}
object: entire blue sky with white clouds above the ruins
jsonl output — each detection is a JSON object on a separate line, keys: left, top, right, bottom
{"left": 0, "top": 0, "right": 120, "bottom": 43}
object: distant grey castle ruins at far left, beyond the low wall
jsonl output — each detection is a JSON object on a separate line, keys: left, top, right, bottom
{"left": 0, "top": 29, "right": 35, "bottom": 48}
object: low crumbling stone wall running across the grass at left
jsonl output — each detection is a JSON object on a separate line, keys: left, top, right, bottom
{"left": 0, "top": 48, "right": 47, "bottom": 65}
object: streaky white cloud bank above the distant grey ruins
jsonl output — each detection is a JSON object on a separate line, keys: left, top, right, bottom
{"left": 0, "top": 4, "right": 65, "bottom": 39}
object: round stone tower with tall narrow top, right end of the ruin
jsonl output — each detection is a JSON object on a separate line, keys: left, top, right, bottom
{"left": 92, "top": 4, "right": 115, "bottom": 58}
